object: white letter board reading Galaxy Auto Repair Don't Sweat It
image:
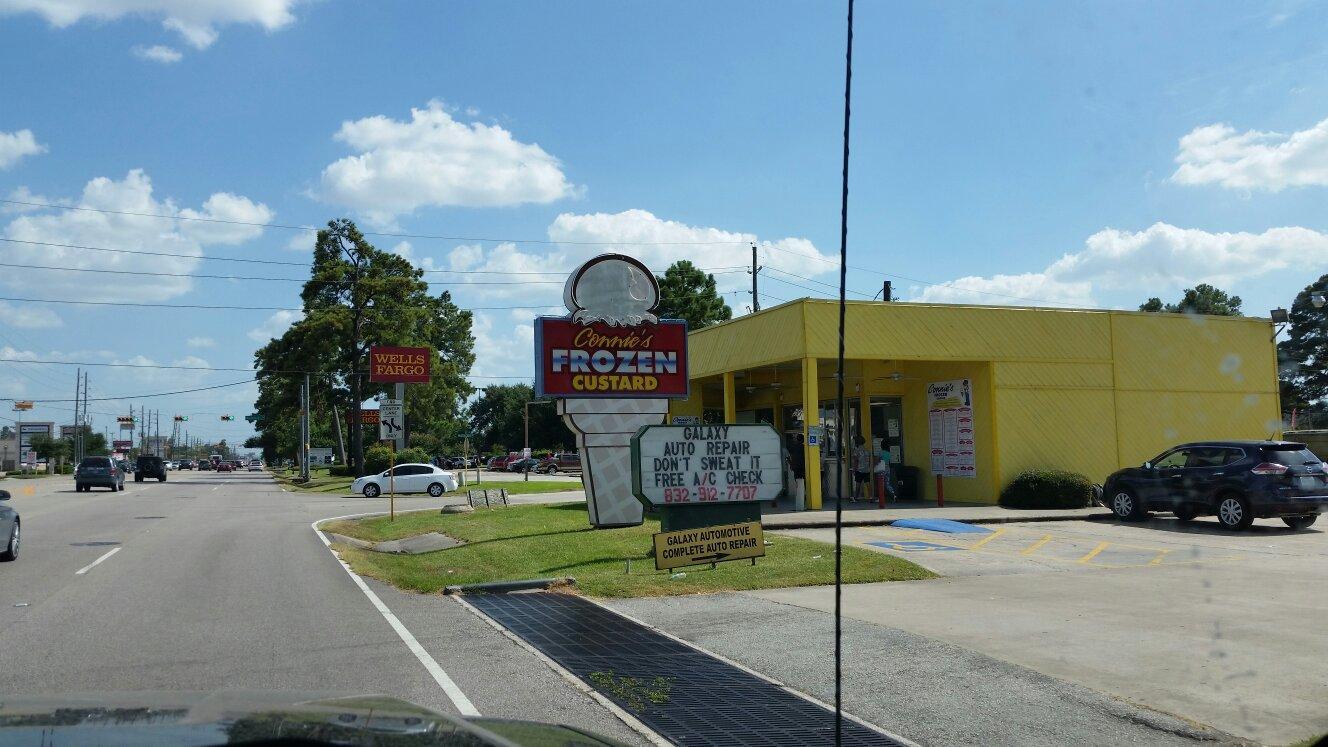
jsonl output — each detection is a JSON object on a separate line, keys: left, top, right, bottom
{"left": 632, "top": 424, "right": 785, "bottom": 506}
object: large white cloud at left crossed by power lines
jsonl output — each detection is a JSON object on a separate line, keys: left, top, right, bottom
{"left": 0, "top": 169, "right": 272, "bottom": 302}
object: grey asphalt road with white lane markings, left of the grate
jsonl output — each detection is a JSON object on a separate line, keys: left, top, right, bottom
{"left": 0, "top": 472, "right": 644, "bottom": 744}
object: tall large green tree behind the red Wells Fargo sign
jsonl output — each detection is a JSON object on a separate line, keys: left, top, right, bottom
{"left": 254, "top": 219, "right": 474, "bottom": 475}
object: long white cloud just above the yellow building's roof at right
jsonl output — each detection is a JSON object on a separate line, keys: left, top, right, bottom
{"left": 914, "top": 223, "right": 1328, "bottom": 306}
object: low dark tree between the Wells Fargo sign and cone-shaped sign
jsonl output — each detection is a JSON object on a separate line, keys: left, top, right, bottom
{"left": 470, "top": 384, "right": 575, "bottom": 453}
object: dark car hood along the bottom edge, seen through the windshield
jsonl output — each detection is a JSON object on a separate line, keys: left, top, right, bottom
{"left": 0, "top": 690, "right": 629, "bottom": 747}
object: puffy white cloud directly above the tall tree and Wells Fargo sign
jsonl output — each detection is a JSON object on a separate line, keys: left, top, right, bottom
{"left": 319, "top": 101, "right": 580, "bottom": 223}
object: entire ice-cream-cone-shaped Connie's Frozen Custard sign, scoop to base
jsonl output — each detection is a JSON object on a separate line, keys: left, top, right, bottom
{"left": 535, "top": 254, "right": 689, "bottom": 526}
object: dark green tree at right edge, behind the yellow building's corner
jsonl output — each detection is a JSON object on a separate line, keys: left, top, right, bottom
{"left": 1278, "top": 275, "right": 1328, "bottom": 428}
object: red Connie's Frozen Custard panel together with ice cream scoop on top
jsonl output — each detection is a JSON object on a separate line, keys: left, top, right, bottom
{"left": 535, "top": 254, "right": 689, "bottom": 399}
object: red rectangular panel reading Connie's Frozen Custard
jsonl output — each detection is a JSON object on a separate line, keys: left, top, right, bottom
{"left": 535, "top": 316, "right": 689, "bottom": 399}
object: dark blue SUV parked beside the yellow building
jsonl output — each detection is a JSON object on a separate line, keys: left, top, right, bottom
{"left": 1102, "top": 441, "right": 1328, "bottom": 529}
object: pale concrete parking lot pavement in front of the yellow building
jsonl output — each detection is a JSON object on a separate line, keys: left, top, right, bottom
{"left": 752, "top": 517, "right": 1328, "bottom": 743}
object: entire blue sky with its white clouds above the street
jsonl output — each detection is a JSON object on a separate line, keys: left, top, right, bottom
{"left": 0, "top": 0, "right": 1328, "bottom": 439}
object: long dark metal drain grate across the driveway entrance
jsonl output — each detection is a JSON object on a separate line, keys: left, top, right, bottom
{"left": 466, "top": 593, "right": 899, "bottom": 747}
